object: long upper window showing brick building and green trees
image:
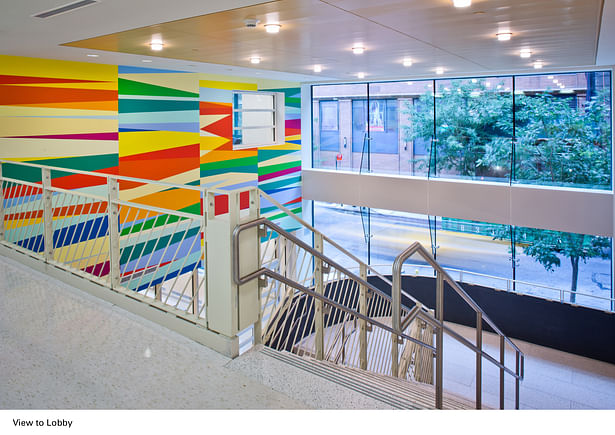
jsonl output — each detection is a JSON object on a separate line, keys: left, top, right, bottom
{"left": 312, "top": 71, "right": 612, "bottom": 189}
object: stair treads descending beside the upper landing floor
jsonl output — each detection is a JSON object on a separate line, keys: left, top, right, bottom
{"left": 260, "top": 347, "right": 475, "bottom": 409}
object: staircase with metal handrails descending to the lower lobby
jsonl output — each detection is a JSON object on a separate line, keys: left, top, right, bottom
{"left": 232, "top": 191, "right": 524, "bottom": 409}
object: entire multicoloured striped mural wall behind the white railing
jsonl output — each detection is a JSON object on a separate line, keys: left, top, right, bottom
{"left": 0, "top": 56, "right": 301, "bottom": 290}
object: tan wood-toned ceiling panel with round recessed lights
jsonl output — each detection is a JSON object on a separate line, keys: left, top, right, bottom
{"left": 66, "top": 0, "right": 603, "bottom": 79}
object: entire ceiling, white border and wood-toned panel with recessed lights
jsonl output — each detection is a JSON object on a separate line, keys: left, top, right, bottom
{"left": 0, "top": 0, "right": 614, "bottom": 80}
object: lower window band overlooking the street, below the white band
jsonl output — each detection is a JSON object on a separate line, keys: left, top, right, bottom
{"left": 314, "top": 201, "right": 615, "bottom": 311}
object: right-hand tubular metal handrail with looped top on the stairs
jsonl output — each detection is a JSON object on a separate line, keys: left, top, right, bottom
{"left": 391, "top": 242, "right": 525, "bottom": 409}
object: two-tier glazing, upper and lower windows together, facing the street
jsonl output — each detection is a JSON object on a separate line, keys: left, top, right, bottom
{"left": 304, "top": 70, "right": 615, "bottom": 311}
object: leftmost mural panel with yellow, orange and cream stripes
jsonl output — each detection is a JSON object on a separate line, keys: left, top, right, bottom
{"left": 0, "top": 56, "right": 118, "bottom": 194}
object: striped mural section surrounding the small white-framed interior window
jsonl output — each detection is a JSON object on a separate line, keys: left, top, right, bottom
{"left": 200, "top": 80, "right": 301, "bottom": 230}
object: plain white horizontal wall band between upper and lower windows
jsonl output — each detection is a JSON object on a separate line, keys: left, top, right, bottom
{"left": 303, "top": 169, "right": 615, "bottom": 237}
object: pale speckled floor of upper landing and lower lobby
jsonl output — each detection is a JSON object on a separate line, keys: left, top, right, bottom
{"left": 0, "top": 257, "right": 615, "bottom": 409}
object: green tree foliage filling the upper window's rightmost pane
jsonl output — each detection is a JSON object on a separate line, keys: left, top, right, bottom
{"left": 515, "top": 89, "right": 611, "bottom": 188}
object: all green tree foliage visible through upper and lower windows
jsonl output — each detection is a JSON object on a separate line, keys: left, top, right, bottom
{"left": 403, "top": 75, "right": 611, "bottom": 302}
